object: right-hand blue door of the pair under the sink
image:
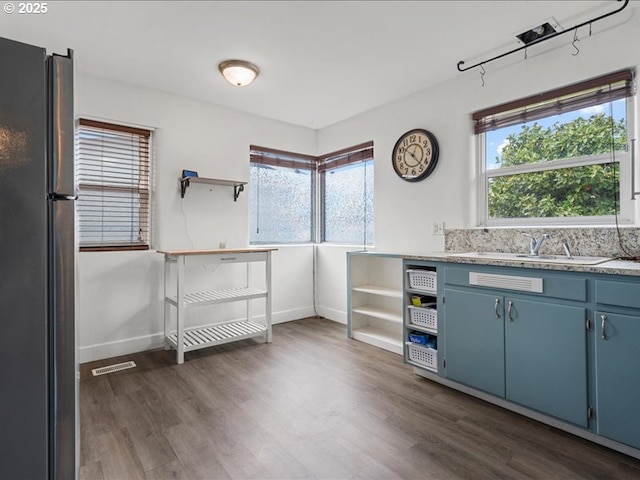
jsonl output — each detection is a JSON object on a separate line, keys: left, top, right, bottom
{"left": 505, "top": 297, "right": 587, "bottom": 427}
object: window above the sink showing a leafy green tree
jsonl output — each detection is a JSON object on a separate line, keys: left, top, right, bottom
{"left": 473, "top": 71, "right": 633, "bottom": 225}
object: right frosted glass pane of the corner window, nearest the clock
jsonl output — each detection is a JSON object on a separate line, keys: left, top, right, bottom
{"left": 322, "top": 160, "right": 374, "bottom": 245}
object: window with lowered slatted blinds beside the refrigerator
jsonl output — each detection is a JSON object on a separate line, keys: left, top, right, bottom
{"left": 76, "top": 119, "right": 151, "bottom": 251}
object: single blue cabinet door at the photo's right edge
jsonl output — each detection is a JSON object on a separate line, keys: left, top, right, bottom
{"left": 595, "top": 312, "right": 640, "bottom": 448}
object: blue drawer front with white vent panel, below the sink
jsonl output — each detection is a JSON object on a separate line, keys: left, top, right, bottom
{"left": 445, "top": 266, "right": 587, "bottom": 301}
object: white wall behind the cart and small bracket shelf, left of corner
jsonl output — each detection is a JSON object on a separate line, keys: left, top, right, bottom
{"left": 75, "top": 74, "right": 317, "bottom": 362}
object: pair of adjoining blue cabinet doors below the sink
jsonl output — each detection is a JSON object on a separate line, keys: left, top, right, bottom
{"left": 444, "top": 288, "right": 588, "bottom": 427}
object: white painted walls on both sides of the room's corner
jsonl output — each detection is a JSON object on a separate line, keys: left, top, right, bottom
{"left": 76, "top": 9, "right": 640, "bottom": 362}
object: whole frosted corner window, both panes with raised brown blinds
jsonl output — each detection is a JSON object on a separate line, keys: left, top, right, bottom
{"left": 249, "top": 142, "right": 373, "bottom": 244}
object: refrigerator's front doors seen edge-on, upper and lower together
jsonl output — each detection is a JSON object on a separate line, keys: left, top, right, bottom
{"left": 48, "top": 50, "right": 78, "bottom": 480}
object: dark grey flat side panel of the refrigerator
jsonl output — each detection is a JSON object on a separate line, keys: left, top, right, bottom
{"left": 0, "top": 38, "right": 48, "bottom": 479}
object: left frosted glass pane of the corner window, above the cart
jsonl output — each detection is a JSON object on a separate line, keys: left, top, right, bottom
{"left": 249, "top": 163, "right": 314, "bottom": 244}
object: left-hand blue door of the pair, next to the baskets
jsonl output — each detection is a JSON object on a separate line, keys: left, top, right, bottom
{"left": 444, "top": 288, "right": 504, "bottom": 397}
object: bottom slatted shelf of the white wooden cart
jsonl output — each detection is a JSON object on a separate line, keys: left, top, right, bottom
{"left": 167, "top": 321, "right": 267, "bottom": 352}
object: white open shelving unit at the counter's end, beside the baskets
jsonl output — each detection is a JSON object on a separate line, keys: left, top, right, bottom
{"left": 347, "top": 252, "right": 403, "bottom": 355}
